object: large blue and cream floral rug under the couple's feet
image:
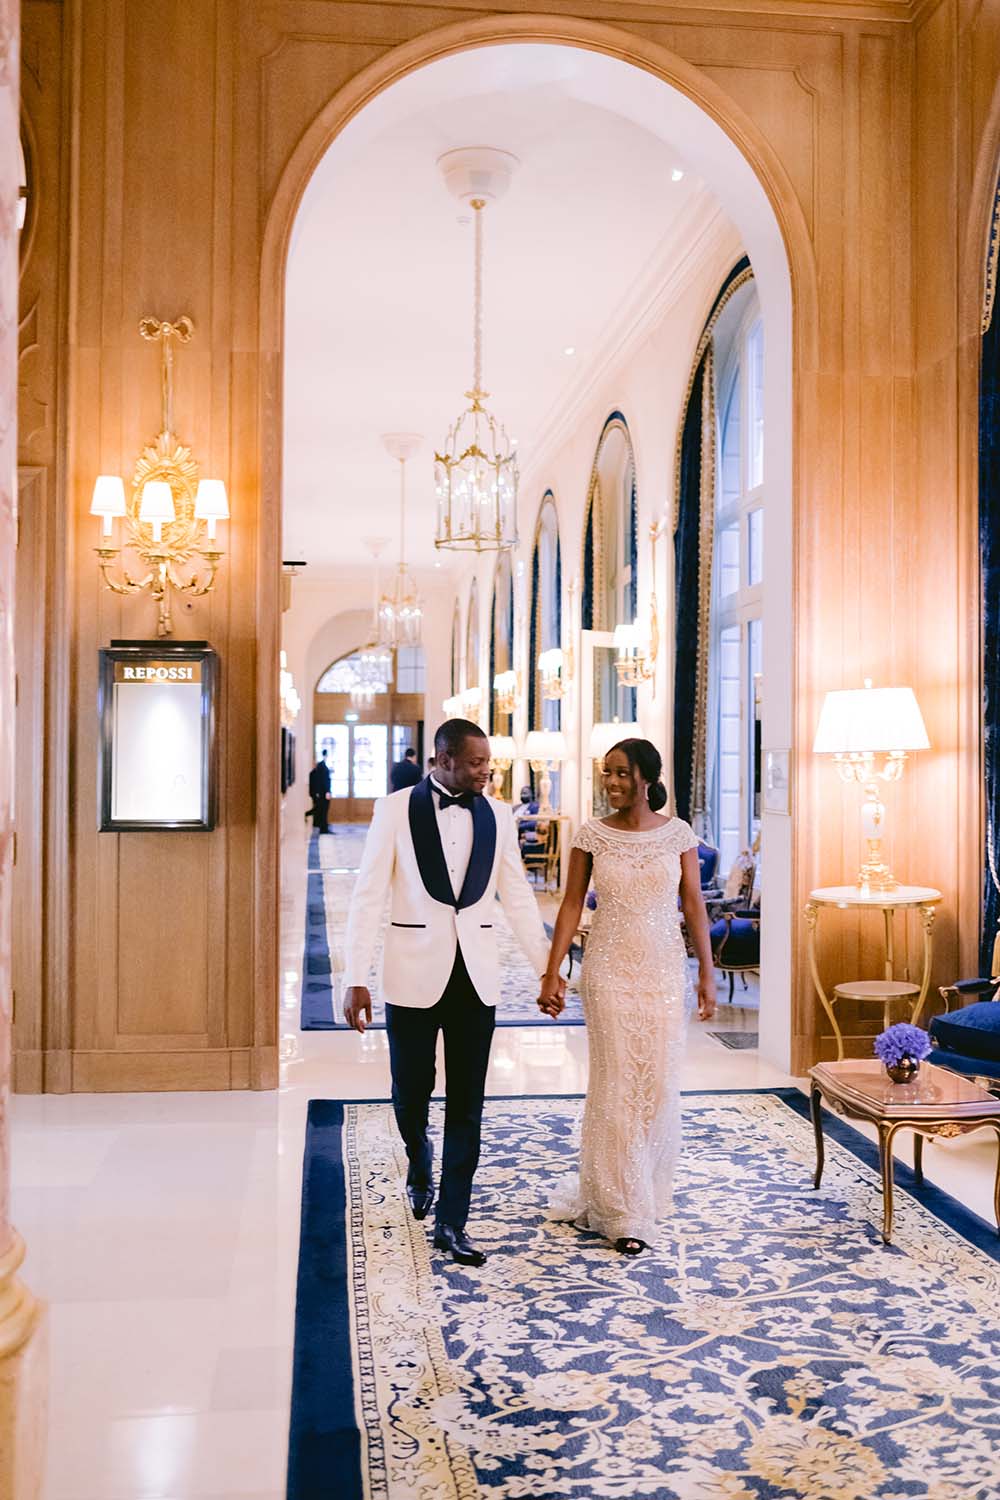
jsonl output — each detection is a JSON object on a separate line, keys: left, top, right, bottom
{"left": 288, "top": 1089, "right": 1000, "bottom": 1500}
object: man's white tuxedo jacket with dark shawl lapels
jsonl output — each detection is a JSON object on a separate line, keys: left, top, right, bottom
{"left": 343, "top": 777, "right": 549, "bottom": 1010}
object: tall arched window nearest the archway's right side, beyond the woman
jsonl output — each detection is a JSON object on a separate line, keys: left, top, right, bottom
{"left": 709, "top": 294, "right": 765, "bottom": 872}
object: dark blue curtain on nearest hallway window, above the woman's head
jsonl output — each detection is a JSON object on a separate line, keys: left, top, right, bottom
{"left": 673, "top": 356, "right": 705, "bottom": 822}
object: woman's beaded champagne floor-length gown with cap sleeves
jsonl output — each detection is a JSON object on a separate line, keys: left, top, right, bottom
{"left": 559, "top": 818, "right": 697, "bottom": 1242}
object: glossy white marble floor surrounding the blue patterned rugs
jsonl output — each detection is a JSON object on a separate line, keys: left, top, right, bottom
{"left": 12, "top": 825, "right": 996, "bottom": 1500}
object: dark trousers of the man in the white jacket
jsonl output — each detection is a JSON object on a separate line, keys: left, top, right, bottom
{"left": 385, "top": 948, "right": 496, "bottom": 1229}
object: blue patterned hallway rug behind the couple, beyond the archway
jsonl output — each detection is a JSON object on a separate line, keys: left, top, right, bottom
{"left": 301, "top": 824, "right": 583, "bottom": 1031}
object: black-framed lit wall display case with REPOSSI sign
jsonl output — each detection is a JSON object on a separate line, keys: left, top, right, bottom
{"left": 99, "top": 641, "right": 219, "bottom": 833}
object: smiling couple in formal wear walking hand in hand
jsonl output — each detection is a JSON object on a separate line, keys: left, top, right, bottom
{"left": 343, "top": 719, "right": 715, "bottom": 1266}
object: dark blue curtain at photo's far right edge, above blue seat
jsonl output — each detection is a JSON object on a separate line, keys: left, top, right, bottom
{"left": 979, "top": 181, "right": 1000, "bottom": 974}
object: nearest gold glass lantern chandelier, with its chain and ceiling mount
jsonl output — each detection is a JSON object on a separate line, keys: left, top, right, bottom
{"left": 435, "top": 146, "right": 517, "bottom": 552}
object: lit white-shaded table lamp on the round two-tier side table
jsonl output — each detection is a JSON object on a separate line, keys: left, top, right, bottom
{"left": 813, "top": 678, "right": 931, "bottom": 891}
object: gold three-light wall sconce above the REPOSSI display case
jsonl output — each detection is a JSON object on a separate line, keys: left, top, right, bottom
{"left": 90, "top": 318, "right": 229, "bottom": 636}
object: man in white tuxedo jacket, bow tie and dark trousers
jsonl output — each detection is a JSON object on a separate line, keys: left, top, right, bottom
{"left": 343, "top": 719, "right": 563, "bottom": 1266}
